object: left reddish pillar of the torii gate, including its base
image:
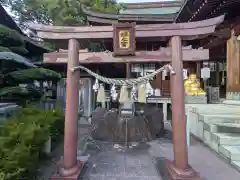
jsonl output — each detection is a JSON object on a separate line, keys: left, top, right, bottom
{"left": 51, "top": 39, "right": 83, "bottom": 180}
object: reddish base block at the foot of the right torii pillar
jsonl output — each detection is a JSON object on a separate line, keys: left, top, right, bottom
{"left": 166, "top": 160, "right": 201, "bottom": 180}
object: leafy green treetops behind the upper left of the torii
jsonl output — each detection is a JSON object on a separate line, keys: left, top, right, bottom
{"left": 0, "top": 0, "right": 122, "bottom": 26}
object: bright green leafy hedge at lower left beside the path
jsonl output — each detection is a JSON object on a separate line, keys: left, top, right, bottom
{"left": 0, "top": 107, "right": 64, "bottom": 180}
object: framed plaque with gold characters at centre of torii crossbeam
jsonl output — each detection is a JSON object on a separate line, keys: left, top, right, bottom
{"left": 113, "top": 23, "right": 136, "bottom": 56}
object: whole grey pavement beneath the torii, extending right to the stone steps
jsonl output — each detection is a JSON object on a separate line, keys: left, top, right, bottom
{"left": 80, "top": 129, "right": 240, "bottom": 180}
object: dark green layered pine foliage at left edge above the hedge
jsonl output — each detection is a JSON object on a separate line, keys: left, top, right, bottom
{"left": 0, "top": 25, "right": 61, "bottom": 104}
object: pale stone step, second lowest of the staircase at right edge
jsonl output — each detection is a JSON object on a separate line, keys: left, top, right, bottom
{"left": 218, "top": 145, "right": 240, "bottom": 161}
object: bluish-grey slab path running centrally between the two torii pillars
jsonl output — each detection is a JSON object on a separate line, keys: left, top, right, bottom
{"left": 81, "top": 143, "right": 161, "bottom": 180}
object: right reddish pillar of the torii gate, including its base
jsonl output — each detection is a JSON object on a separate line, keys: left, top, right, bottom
{"left": 166, "top": 36, "right": 200, "bottom": 180}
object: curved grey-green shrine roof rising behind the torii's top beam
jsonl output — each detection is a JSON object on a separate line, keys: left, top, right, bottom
{"left": 82, "top": 1, "right": 182, "bottom": 24}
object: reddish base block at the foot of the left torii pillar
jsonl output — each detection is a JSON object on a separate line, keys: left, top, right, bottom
{"left": 50, "top": 161, "right": 84, "bottom": 180}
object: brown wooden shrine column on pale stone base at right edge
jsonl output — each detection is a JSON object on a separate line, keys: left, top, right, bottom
{"left": 223, "top": 31, "right": 240, "bottom": 106}
